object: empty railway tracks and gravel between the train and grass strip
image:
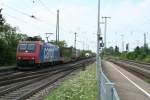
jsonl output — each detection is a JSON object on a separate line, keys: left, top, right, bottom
{"left": 0, "top": 58, "right": 95, "bottom": 100}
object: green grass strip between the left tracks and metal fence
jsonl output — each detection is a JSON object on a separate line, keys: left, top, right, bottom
{"left": 44, "top": 64, "right": 97, "bottom": 100}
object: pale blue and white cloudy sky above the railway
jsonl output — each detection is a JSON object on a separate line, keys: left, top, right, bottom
{"left": 0, "top": 0, "right": 150, "bottom": 51}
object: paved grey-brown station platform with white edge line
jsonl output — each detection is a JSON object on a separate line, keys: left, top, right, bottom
{"left": 102, "top": 61, "right": 150, "bottom": 100}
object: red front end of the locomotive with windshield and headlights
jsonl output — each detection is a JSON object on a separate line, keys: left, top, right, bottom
{"left": 16, "top": 41, "right": 38, "bottom": 67}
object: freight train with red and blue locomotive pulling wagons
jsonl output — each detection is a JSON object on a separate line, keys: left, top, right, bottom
{"left": 16, "top": 40, "right": 80, "bottom": 69}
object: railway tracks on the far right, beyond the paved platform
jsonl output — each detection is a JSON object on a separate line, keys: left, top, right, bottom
{"left": 109, "top": 59, "right": 150, "bottom": 80}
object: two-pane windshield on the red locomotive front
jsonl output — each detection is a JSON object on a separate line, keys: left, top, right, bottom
{"left": 18, "top": 43, "right": 35, "bottom": 52}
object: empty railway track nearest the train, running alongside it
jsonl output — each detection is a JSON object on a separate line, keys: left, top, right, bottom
{"left": 0, "top": 59, "right": 92, "bottom": 86}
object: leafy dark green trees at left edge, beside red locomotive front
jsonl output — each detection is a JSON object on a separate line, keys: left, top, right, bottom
{"left": 0, "top": 9, "right": 27, "bottom": 65}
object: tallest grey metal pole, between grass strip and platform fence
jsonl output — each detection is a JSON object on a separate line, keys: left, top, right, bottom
{"left": 96, "top": 0, "right": 101, "bottom": 100}
